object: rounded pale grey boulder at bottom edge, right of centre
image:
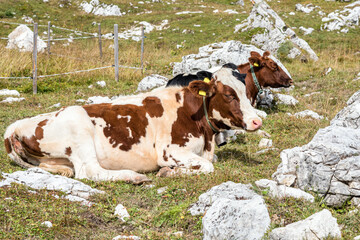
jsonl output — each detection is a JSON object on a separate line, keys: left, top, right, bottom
{"left": 190, "top": 182, "right": 270, "bottom": 240}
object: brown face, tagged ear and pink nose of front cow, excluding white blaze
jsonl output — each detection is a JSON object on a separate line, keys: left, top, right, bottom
{"left": 189, "top": 79, "right": 261, "bottom": 130}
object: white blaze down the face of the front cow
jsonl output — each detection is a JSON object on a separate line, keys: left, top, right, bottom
{"left": 214, "top": 68, "right": 261, "bottom": 130}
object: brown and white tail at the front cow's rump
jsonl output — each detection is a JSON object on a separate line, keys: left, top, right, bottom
{"left": 4, "top": 128, "right": 35, "bottom": 168}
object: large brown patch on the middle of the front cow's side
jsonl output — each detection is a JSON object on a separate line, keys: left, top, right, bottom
{"left": 83, "top": 97, "right": 164, "bottom": 151}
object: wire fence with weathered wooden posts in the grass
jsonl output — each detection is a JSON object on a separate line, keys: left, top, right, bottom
{"left": 0, "top": 21, "right": 145, "bottom": 94}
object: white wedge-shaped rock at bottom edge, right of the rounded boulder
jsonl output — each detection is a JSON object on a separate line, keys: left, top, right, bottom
{"left": 269, "top": 209, "right": 341, "bottom": 240}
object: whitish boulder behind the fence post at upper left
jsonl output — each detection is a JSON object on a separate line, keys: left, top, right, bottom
{"left": 6, "top": 25, "right": 46, "bottom": 52}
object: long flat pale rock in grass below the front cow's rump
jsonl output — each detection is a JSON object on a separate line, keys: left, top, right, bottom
{"left": 0, "top": 168, "right": 104, "bottom": 199}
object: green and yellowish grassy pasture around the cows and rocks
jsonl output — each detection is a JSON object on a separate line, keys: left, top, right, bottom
{"left": 0, "top": 0, "right": 360, "bottom": 239}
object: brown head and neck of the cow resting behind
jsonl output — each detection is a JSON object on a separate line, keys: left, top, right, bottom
{"left": 237, "top": 51, "right": 293, "bottom": 105}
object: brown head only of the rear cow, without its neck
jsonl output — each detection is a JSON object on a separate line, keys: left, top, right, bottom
{"left": 249, "top": 51, "right": 293, "bottom": 88}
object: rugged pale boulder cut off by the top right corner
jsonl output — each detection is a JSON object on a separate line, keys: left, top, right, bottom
{"left": 321, "top": 1, "right": 360, "bottom": 33}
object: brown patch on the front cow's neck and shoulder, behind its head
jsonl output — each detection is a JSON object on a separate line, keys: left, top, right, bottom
{"left": 171, "top": 89, "right": 213, "bottom": 151}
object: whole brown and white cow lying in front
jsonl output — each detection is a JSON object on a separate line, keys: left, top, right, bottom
{"left": 4, "top": 69, "right": 261, "bottom": 184}
